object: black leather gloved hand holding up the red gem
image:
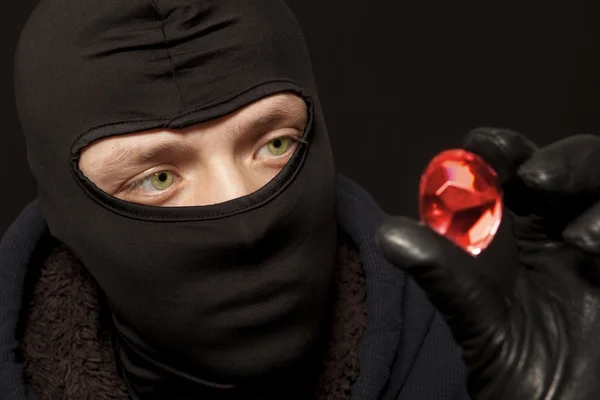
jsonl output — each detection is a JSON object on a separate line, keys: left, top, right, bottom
{"left": 377, "top": 128, "right": 600, "bottom": 400}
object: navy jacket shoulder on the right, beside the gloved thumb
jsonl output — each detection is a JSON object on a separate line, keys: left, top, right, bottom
{"left": 337, "top": 174, "right": 466, "bottom": 400}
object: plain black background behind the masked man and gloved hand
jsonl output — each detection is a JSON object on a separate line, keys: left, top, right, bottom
{"left": 0, "top": 0, "right": 600, "bottom": 262}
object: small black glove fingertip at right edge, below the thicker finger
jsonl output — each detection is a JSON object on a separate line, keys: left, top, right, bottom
{"left": 563, "top": 202, "right": 600, "bottom": 256}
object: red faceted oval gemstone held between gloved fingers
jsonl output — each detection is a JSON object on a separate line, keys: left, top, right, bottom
{"left": 419, "top": 149, "right": 502, "bottom": 255}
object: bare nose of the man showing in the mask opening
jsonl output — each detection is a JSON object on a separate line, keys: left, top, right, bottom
{"left": 195, "top": 158, "right": 255, "bottom": 205}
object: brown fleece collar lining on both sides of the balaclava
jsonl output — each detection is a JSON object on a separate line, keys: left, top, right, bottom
{"left": 22, "top": 241, "right": 366, "bottom": 400}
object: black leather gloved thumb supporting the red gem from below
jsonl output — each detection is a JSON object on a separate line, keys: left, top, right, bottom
{"left": 376, "top": 217, "right": 506, "bottom": 343}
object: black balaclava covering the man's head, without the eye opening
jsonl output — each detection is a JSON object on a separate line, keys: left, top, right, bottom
{"left": 15, "top": 0, "right": 336, "bottom": 399}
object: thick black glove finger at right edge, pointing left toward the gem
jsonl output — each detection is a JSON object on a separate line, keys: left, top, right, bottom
{"left": 518, "top": 135, "right": 600, "bottom": 196}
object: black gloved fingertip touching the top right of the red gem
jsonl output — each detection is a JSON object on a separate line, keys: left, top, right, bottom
{"left": 463, "top": 128, "right": 537, "bottom": 184}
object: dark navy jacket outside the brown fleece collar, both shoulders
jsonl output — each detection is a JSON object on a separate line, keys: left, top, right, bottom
{"left": 0, "top": 175, "right": 468, "bottom": 400}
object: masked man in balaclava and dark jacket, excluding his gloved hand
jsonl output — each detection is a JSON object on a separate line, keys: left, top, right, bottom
{"left": 0, "top": 0, "right": 466, "bottom": 400}
